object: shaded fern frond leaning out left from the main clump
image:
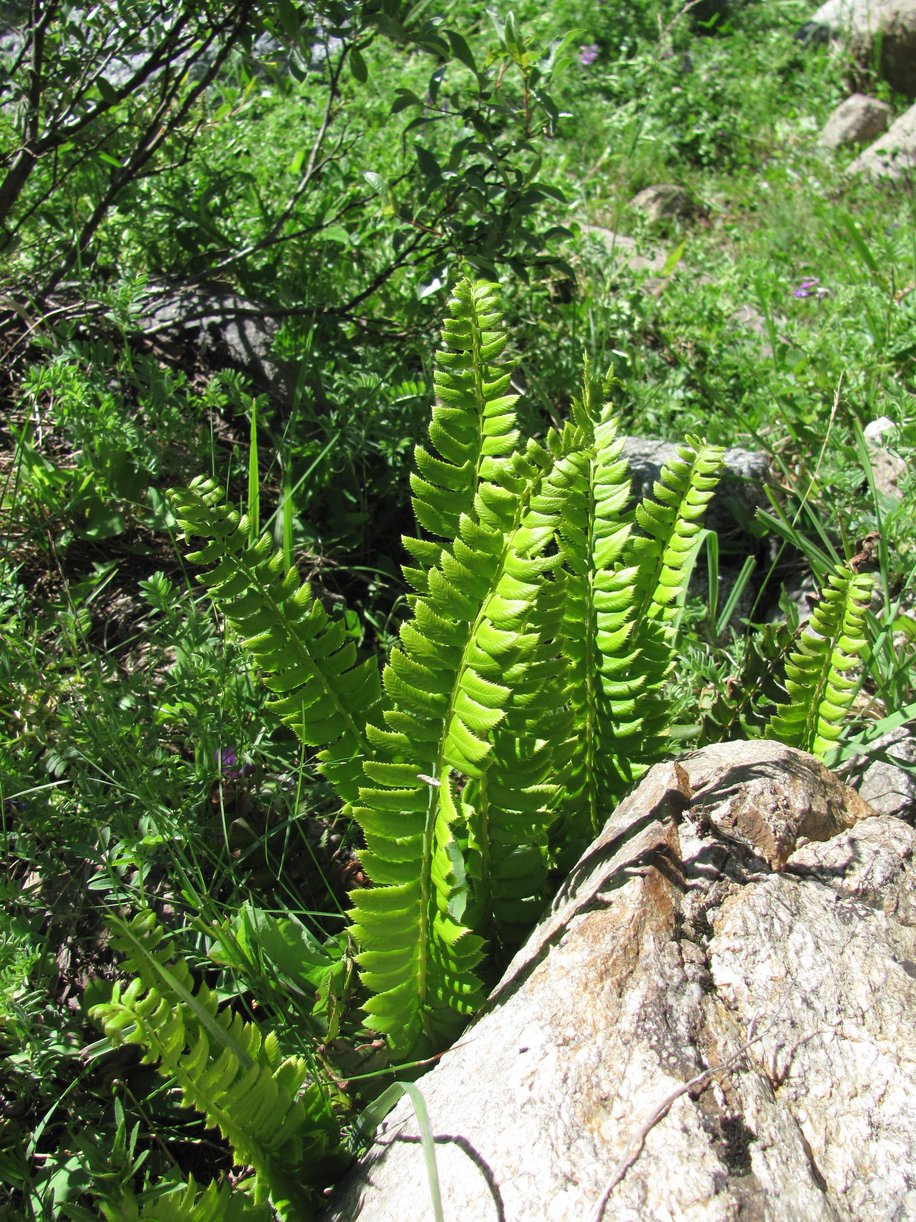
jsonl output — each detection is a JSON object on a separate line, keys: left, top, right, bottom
{"left": 170, "top": 479, "right": 380, "bottom": 803}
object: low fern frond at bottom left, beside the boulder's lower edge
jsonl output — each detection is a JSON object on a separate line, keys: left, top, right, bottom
{"left": 90, "top": 912, "right": 341, "bottom": 1220}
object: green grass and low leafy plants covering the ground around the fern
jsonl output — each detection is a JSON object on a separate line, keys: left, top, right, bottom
{"left": 0, "top": 0, "right": 916, "bottom": 1218}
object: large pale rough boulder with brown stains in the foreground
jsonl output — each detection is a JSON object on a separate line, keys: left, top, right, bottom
{"left": 324, "top": 743, "right": 916, "bottom": 1222}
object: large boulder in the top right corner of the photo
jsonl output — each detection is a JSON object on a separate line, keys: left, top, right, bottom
{"left": 805, "top": 0, "right": 916, "bottom": 98}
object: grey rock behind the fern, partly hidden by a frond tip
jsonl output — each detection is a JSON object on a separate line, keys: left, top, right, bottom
{"left": 623, "top": 437, "right": 769, "bottom": 538}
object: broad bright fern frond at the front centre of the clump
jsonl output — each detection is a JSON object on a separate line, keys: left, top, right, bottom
{"left": 352, "top": 420, "right": 571, "bottom": 1050}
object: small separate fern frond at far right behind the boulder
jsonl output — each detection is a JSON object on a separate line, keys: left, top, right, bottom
{"left": 766, "top": 565, "right": 874, "bottom": 758}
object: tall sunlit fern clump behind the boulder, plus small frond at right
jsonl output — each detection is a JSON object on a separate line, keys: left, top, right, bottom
{"left": 159, "top": 281, "right": 865, "bottom": 1056}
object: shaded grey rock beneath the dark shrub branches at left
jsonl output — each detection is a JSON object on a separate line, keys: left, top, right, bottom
{"left": 138, "top": 285, "right": 294, "bottom": 403}
